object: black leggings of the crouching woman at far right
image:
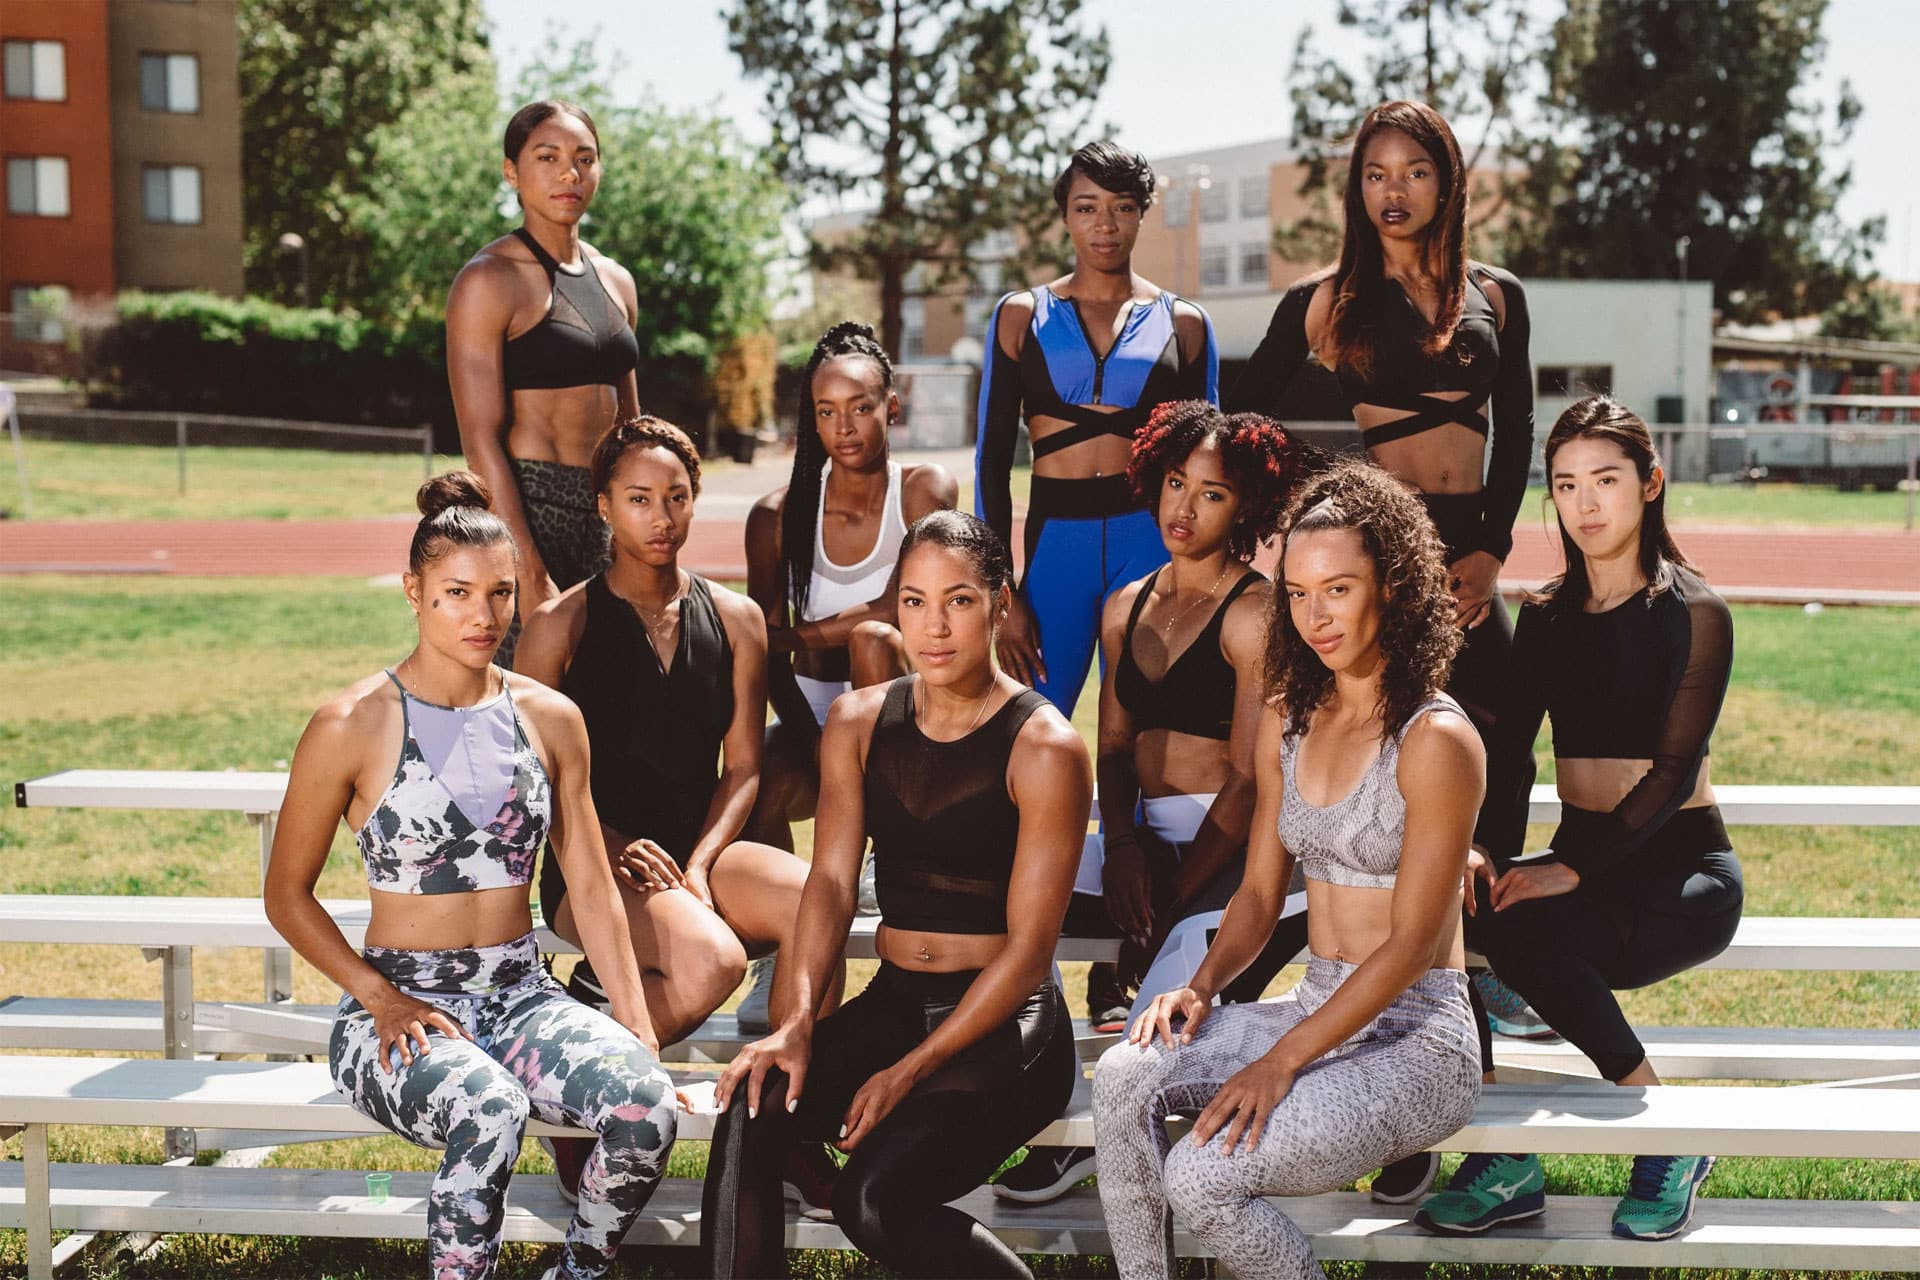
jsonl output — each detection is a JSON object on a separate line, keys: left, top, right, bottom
{"left": 1467, "top": 806, "right": 1745, "bottom": 1080}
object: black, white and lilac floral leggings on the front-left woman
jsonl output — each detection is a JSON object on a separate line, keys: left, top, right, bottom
{"left": 326, "top": 933, "right": 676, "bottom": 1280}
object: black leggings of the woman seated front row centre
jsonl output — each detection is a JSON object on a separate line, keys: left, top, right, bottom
{"left": 701, "top": 963, "right": 1079, "bottom": 1280}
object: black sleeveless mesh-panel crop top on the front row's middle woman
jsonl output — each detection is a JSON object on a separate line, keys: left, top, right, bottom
{"left": 866, "top": 676, "right": 1046, "bottom": 935}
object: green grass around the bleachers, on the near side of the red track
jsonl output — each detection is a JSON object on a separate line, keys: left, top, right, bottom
{"left": 0, "top": 578, "right": 1920, "bottom": 1280}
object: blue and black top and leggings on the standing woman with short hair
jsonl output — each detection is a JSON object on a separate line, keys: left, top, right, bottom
{"left": 973, "top": 286, "right": 1219, "bottom": 716}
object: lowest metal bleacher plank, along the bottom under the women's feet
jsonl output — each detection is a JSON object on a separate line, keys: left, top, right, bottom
{"left": 0, "top": 1165, "right": 1920, "bottom": 1270}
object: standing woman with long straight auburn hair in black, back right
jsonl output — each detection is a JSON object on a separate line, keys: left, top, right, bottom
{"left": 1225, "top": 102, "right": 1534, "bottom": 737}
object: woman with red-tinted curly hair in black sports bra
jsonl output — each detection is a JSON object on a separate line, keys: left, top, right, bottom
{"left": 995, "top": 399, "right": 1309, "bottom": 1203}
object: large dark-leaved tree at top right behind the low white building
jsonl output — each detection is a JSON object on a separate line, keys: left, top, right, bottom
{"left": 1507, "top": 0, "right": 1882, "bottom": 320}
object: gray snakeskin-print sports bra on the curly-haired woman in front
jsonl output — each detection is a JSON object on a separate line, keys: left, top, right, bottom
{"left": 1281, "top": 693, "right": 1467, "bottom": 889}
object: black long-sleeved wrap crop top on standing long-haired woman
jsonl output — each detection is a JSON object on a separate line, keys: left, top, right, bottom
{"left": 1225, "top": 263, "right": 1534, "bottom": 560}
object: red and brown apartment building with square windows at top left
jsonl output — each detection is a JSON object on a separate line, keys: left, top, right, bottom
{"left": 0, "top": 0, "right": 242, "bottom": 368}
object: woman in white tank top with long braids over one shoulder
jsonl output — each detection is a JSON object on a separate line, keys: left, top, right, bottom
{"left": 747, "top": 320, "right": 958, "bottom": 848}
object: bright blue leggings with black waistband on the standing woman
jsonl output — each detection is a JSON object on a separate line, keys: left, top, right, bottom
{"left": 1020, "top": 476, "right": 1169, "bottom": 720}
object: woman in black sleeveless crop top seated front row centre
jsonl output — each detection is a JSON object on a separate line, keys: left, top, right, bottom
{"left": 701, "top": 510, "right": 1092, "bottom": 1278}
